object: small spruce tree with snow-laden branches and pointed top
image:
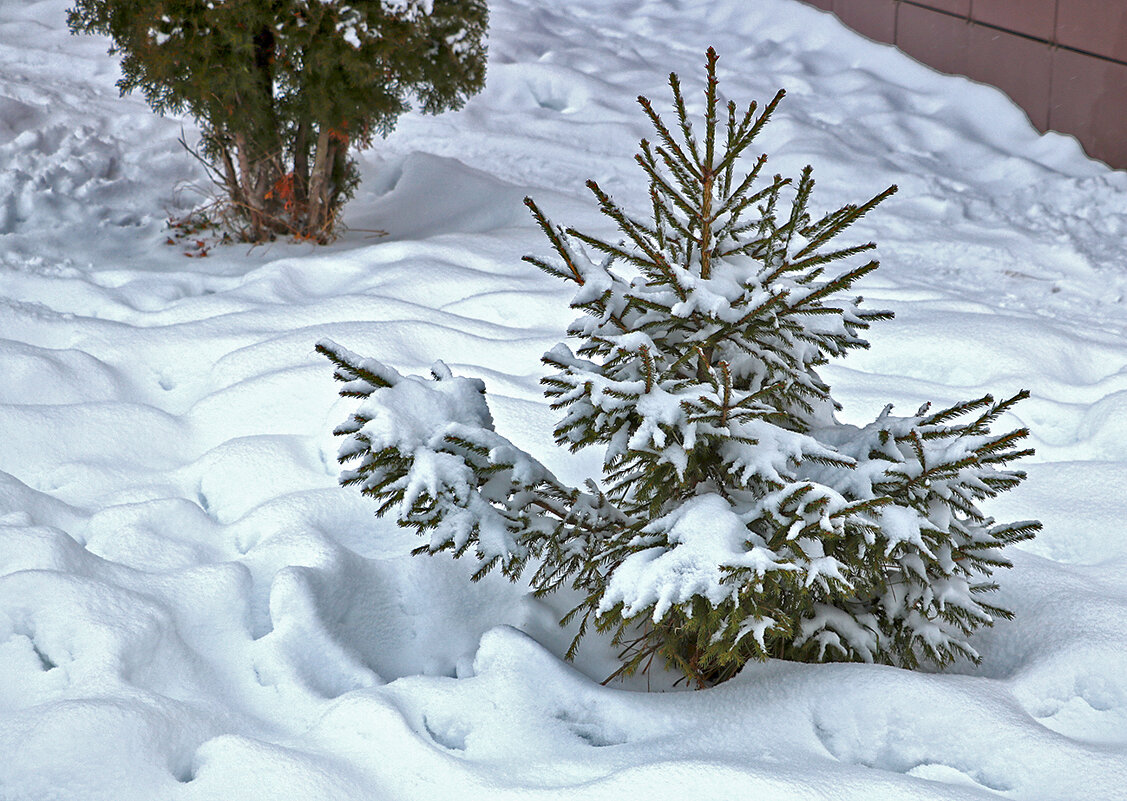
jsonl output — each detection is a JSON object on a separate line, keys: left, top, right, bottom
{"left": 318, "top": 50, "right": 1039, "bottom": 685}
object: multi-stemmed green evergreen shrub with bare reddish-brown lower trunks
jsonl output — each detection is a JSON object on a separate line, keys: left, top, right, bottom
{"left": 69, "top": 0, "right": 488, "bottom": 242}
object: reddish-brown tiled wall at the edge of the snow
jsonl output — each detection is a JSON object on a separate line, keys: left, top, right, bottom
{"left": 806, "top": 0, "right": 1127, "bottom": 169}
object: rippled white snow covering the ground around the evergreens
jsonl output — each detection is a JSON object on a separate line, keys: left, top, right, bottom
{"left": 0, "top": 0, "right": 1127, "bottom": 801}
